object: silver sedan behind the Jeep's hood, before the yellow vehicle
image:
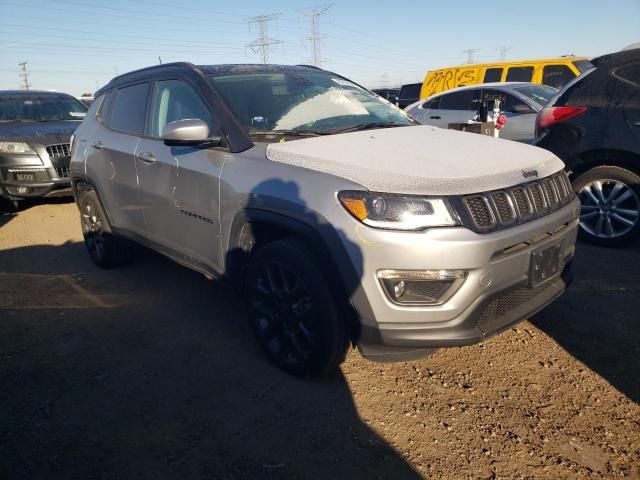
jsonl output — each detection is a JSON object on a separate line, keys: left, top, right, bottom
{"left": 405, "top": 82, "right": 558, "bottom": 143}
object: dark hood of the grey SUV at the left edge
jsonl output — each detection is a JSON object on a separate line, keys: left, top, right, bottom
{"left": 0, "top": 120, "right": 80, "bottom": 145}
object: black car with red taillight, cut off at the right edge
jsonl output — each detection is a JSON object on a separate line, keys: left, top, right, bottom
{"left": 536, "top": 49, "right": 640, "bottom": 246}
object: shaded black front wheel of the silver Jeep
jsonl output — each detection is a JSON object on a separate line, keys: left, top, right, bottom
{"left": 243, "top": 239, "right": 349, "bottom": 378}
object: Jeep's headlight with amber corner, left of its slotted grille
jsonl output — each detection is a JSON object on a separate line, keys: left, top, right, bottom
{"left": 338, "top": 191, "right": 460, "bottom": 230}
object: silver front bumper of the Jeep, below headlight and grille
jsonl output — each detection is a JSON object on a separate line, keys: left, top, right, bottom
{"left": 330, "top": 196, "right": 579, "bottom": 360}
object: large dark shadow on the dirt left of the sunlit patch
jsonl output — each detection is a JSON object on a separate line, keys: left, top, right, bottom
{"left": 0, "top": 242, "right": 419, "bottom": 480}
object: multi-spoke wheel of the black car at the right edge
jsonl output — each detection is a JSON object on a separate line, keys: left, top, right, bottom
{"left": 572, "top": 166, "right": 640, "bottom": 247}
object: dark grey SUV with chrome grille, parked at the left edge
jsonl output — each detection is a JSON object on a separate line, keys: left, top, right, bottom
{"left": 0, "top": 90, "right": 87, "bottom": 209}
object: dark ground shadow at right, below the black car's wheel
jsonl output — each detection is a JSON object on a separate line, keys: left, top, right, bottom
{"left": 531, "top": 243, "right": 640, "bottom": 403}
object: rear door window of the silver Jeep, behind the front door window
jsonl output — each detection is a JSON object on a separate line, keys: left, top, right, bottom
{"left": 109, "top": 83, "right": 149, "bottom": 135}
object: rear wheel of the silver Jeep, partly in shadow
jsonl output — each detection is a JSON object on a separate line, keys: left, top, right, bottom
{"left": 79, "top": 190, "right": 131, "bottom": 269}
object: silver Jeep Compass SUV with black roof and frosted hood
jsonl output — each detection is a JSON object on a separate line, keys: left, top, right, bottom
{"left": 71, "top": 63, "right": 579, "bottom": 376}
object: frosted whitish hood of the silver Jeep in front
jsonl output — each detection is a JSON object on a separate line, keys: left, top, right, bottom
{"left": 266, "top": 125, "right": 564, "bottom": 195}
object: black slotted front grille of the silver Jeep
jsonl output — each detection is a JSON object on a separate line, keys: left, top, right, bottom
{"left": 456, "top": 172, "right": 575, "bottom": 233}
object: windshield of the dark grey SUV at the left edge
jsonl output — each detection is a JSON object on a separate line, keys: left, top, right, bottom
{"left": 0, "top": 95, "right": 87, "bottom": 122}
